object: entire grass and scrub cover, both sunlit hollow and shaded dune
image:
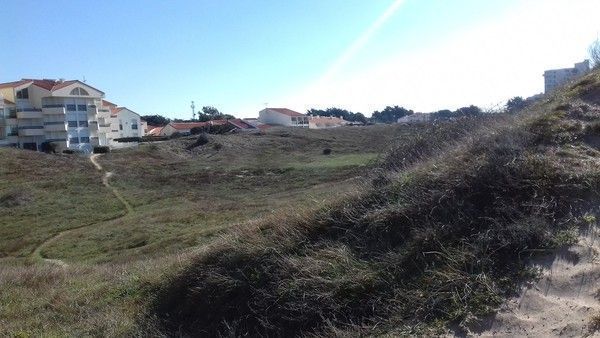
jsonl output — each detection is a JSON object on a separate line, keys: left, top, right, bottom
{"left": 0, "top": 72, "right": 600, "bottom": 336}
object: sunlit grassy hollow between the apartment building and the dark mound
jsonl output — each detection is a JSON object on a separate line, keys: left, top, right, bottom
{"left": 0, "top": 126, "right": 418, "bottom": 336}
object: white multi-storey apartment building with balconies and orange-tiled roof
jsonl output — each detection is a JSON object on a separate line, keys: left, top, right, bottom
{"left": 0, "top": 79, "right": 143, "bottom": 152}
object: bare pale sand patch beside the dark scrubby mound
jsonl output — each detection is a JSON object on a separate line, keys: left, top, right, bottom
{"left": 476, "top": 226, "right": 600, "bottom": 337}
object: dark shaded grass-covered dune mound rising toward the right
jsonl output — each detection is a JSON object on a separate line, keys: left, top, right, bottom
{"left": 152, "top": 74, "right": 600, "bottom": 336}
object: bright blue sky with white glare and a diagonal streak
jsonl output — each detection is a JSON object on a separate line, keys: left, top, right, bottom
{"left": 0, "top": 0, "right": 600, "bottom": 118}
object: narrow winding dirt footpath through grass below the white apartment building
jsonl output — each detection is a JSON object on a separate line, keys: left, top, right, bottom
{"left": 31, "top": 154, "right": 133, "bottom": 268}
